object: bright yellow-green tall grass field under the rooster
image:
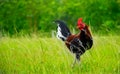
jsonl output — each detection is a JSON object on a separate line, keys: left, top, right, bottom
{"left": 0, "top": 36, "right": 120, "bottom": 74}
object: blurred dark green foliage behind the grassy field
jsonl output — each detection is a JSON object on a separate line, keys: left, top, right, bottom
{"left": 0, "top": 0, "right": 120, "bottom": 36}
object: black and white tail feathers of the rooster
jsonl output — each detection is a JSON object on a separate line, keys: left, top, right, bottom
{"left": 55, "top": 20, "right": 71, "bottom": 41}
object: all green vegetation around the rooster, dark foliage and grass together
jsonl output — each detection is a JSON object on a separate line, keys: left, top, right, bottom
{"left": 0, "top": 0, "right": 120, "bottom": 74}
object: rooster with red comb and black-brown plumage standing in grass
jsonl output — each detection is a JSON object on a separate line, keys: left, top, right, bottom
{"left": 55, "top": 18, "right": 93, "bottom": 66}
